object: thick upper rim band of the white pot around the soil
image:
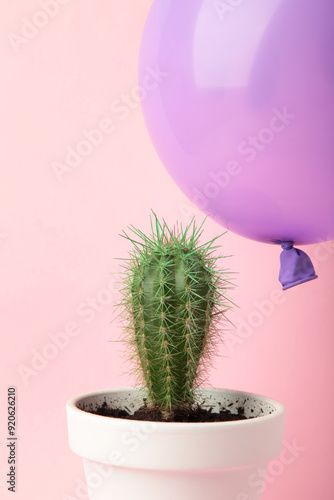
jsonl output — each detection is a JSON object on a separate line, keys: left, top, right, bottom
{"left": 66, "top": 387, "right": 285, "bottom": 470}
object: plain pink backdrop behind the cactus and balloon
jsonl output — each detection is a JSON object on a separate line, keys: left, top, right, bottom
{"left": 0, "top": 0, "right": 334, "bottom": 500}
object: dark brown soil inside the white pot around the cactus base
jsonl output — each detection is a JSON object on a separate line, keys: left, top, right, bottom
{"left": 84, "top": 403, "right": 256, "bottom": 422}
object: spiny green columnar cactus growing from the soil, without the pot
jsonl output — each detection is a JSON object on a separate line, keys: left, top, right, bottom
{"left": 120, "top": 213, "right": 231, "bottom": 420}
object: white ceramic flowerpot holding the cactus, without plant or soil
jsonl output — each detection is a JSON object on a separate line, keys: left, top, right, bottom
{"left": 67, "top": 388, "right": 285, "bottom": 500}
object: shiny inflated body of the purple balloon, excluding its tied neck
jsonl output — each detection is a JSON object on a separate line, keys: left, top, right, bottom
{"left": 139, "top": 0, "right": 334, "bottom": 250}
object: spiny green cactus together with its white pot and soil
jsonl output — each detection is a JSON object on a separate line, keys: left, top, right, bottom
{"left": 67, "top": 214, "right": 285, "bottom": 500}
